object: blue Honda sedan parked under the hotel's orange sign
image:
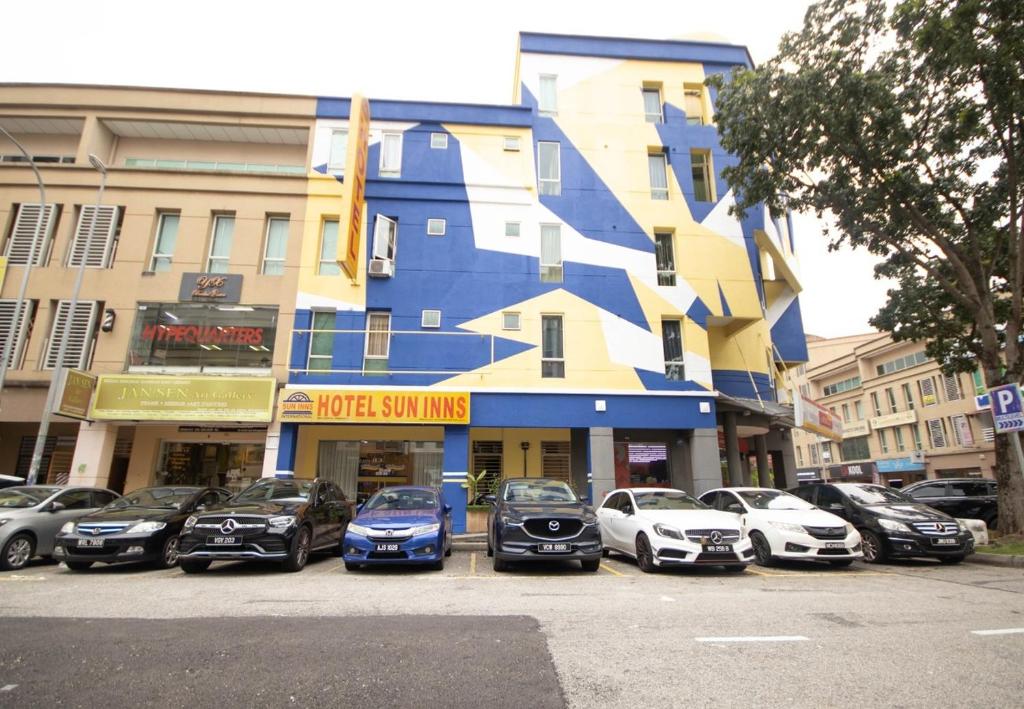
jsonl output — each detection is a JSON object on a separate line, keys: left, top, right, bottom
{"left": 342, "top": 486, "right": 452, "bottom": 571}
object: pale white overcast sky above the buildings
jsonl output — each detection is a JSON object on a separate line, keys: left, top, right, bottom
{"left": 0, "top": 0, "right": 886, "bottom": 337}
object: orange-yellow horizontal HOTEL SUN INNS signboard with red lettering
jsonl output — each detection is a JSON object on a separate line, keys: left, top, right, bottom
{"left": 279, "top": 388, "right": 469, "bottom": 424}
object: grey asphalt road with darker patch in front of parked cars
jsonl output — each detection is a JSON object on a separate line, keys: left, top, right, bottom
{"left": 0, "top": 552, "right": 1024, "bottom": 709}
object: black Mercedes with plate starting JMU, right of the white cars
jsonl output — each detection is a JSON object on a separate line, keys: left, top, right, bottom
{"left": 790, "top": 483, "right": 974, "bottom": 564}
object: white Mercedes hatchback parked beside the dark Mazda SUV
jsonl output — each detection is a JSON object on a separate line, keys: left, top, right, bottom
{"left": 597, "top": 488, "right": 754, "bottom": 574}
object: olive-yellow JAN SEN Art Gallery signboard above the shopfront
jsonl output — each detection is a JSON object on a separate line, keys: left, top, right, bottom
{"left": 91, "top": 374, "right": 278, "bottom": 422}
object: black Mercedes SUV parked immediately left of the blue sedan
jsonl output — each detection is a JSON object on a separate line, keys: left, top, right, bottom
{"left": 178, "top": 477, "right": 352, "bottom": 574}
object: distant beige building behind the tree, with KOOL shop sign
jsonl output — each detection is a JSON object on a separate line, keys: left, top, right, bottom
{"left": 793, "top": 333, "right": 995, "bottom": 487}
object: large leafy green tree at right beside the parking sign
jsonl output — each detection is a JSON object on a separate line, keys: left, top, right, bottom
{"left": 708, "top": 0, "right": 1024, "bottom": 533}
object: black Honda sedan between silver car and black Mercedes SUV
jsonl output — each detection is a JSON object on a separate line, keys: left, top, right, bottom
{"left": 53, "top": 487, "right": 231, "bottom": 571}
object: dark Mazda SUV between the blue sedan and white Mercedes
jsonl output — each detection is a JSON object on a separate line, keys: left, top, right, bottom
{"left": 487, "top": 477, "right": 601, "bottom": 572}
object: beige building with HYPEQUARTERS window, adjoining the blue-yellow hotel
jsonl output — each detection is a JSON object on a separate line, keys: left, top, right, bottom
{"left": 0, "top": 84, "right": 315, "bottom": 490}
